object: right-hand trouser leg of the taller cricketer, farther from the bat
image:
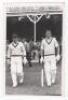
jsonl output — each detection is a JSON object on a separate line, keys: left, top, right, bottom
{"left": 51, "top": 57, "right": 57, "bottom": 84}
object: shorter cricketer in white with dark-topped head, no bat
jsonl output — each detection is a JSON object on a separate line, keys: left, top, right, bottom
{"left": 8, "top": 34, "right": 27, "bottom": 87}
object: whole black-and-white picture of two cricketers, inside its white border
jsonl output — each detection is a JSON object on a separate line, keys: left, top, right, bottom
{"left": 5, "top": 3, "right": 63, "bottom": 96}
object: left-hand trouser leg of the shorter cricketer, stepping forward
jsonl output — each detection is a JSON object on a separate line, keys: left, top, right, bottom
{"left": 11, "top": 58, "right": 17, "bottom": 87}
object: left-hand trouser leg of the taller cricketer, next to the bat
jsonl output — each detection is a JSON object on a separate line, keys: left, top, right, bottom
{"left": 44, "top": 57, "right": 51, "bottom": 86}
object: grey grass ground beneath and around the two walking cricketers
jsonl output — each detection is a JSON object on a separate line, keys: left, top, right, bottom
{"left": 6, "top": 64, "right": 61, "bottom": 96}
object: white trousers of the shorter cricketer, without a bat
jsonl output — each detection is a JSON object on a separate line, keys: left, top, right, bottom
{"left": 11, "top": 56, "right": 24, "bottom": 84}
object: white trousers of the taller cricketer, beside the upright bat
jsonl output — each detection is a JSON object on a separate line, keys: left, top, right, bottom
{"left": 44, "top": 55, "right": 56, "bottom": 86}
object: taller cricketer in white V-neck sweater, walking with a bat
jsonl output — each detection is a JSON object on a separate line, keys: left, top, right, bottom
{"left": 40, "top": 30, "right": 60, "bottom": 86}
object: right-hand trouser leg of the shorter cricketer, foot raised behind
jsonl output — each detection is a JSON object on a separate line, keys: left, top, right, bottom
{"left": 17, "top": 58, "right": 24, "bottom": 83}
